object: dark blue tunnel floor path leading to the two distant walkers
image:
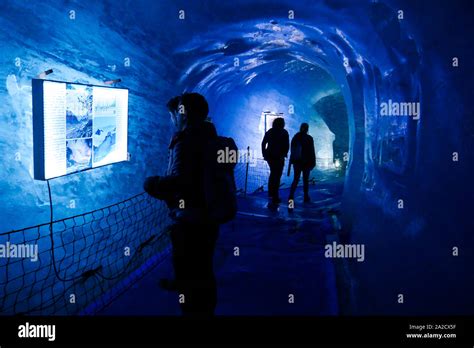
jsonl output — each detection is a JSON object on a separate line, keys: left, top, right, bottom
{"left": 99, "top": 178, "right": 342, "bottom": 315}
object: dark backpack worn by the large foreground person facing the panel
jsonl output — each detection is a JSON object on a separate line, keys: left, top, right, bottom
{"left": 205, "top": 136, "right": 238, "bottom": 224}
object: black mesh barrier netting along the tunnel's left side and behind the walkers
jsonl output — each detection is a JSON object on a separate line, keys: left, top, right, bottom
{"left": 0, "top": 154, "right": 334, "bottom": 315}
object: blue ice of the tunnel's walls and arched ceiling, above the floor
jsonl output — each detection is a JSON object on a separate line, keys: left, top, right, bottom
{"left": 0, "top": 0, "right": 474, "bottom": 313}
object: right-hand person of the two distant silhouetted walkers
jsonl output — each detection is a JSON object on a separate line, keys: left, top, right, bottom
{"left": 289, "top": 123, "right": 316, "bottom": 203}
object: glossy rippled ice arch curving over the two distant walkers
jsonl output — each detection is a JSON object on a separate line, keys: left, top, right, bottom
{"left": 175, "top": 14, "right": 421, "bottom": 230}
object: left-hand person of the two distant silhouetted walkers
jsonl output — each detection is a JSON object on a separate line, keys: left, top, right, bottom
{"left": 262, "top": 117, "right": 290, "bottom": 204}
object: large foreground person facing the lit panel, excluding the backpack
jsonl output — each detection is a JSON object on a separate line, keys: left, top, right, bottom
{"left": 144, "top": 93, "right": 219, "bottom": 316}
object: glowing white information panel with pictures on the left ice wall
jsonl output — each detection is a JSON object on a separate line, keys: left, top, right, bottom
{"left": 32, "top": 79, "right": 128, "bottom": 180}
